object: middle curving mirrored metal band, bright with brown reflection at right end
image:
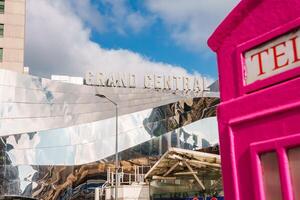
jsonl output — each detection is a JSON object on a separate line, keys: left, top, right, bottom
{"left": 5, "top": 98, "right": 218, "bottom": 165}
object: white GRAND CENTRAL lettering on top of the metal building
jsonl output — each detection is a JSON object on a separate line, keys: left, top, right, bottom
{"left": 85, "top": 72, "right": 206, "bottom": 92}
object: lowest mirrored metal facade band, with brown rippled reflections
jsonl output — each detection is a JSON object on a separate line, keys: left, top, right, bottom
{"left": 0, "top": 118, "right": 218, "bottom": 199}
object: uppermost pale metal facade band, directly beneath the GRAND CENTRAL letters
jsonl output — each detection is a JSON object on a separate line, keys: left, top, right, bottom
{"left": 0, "top": 70, "right": 215, "bottom": 136}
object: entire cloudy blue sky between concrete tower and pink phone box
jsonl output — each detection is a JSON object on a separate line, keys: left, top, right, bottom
{"left": 25, "top": 0, "right": 238, "bottom": 79}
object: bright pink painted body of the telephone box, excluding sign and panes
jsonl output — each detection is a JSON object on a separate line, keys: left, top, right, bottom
{"left": 208, "top": 0, "right": 300, "bottom": 200}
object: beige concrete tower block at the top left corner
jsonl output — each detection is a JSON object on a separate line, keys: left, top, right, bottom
{"left": 0, "top": 0, "right": 25, "bottom": 73}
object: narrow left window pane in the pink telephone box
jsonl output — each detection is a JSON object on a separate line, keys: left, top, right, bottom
{"left": 260, "top": 152, "right": 282, "bottom": 200}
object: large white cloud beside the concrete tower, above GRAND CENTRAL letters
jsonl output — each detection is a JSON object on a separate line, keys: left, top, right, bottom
{"left": 25, "top": 0, "right": 204, "bottom": 83}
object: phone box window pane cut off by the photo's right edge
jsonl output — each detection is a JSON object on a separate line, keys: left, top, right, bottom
{"left": 288, "top": 147, "right": 300, "bottom": 199}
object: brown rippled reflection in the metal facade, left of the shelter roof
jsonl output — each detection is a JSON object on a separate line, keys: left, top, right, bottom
{"left": 28, "top": 159, "right": 147, "bottom": 200}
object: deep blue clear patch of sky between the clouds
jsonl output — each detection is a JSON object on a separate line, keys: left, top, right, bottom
{"left": 91, "top": 0, "right": 217, "bottom": 78}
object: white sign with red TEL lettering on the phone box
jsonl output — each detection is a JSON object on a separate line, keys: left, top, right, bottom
{"left": 244, "top": 29, "right": 300, "bottom": 85}
